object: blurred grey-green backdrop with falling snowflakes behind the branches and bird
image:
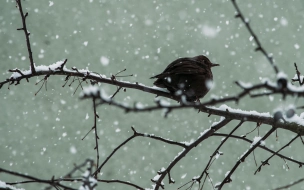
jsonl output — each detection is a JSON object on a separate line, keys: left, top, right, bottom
{"left": 0, "top": 0, "right": 304, "bottom": 190}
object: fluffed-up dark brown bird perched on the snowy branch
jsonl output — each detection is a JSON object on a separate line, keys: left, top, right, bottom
{"left": 151, "top": 55, "right": 219, "bottom": 102}
